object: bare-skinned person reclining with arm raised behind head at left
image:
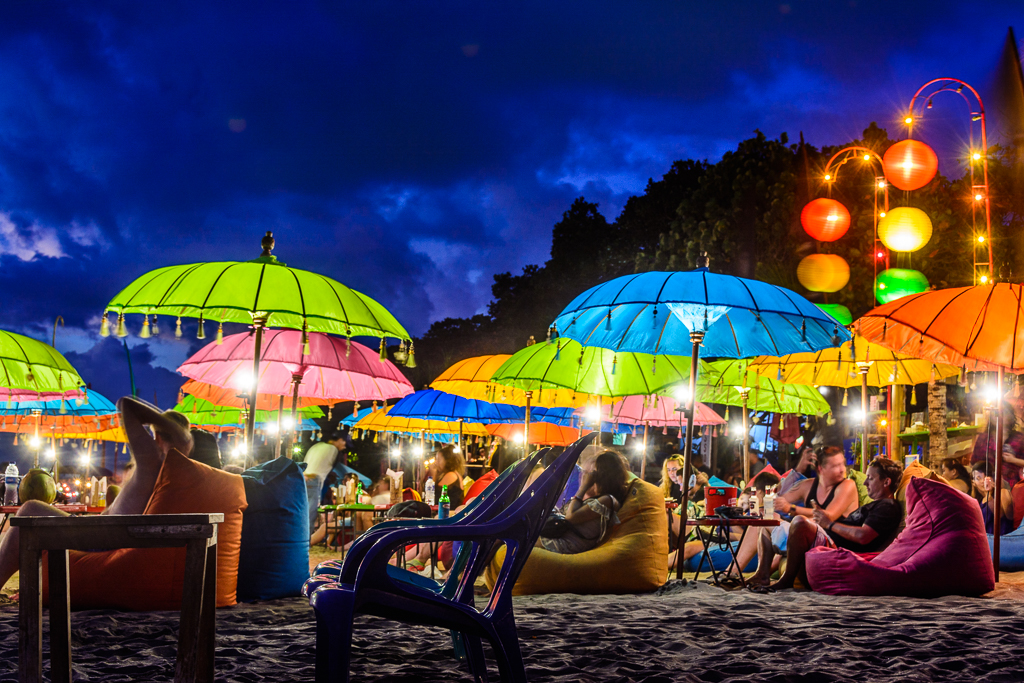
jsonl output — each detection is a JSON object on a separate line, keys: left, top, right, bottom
{"left": 0, "top": 396, "right": 193, "bottom": 586}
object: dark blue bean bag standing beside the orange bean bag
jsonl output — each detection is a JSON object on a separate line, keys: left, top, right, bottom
{"left": 239, "top": 458, "right": 309, "bottom": 602}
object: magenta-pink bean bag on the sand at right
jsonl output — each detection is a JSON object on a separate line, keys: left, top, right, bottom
{"left": 807, "top": 478, "right": 995, "bottom": 598}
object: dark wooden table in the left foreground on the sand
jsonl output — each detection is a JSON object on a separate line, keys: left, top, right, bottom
{"left": 10, "top": 513, "right": 224, "bottom": 683}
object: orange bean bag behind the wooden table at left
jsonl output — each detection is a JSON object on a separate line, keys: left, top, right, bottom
{"left": 43, "top": 451, "right": 246, "bottom": 611}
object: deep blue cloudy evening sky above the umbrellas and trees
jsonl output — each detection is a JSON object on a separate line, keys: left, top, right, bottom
{"left": 0, "top": 0, "right": 1024, "bottom": 402}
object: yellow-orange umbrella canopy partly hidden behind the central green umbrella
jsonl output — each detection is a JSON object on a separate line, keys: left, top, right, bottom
{"left": 430, "top": 353, "right": 610, "bottom": 408}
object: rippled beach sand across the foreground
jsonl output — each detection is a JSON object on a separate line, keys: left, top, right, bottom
{"left": 0, "top": 574, "right": 1024, "bottom": 683}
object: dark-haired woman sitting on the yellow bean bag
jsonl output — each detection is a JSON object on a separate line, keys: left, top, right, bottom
{"left": 537, "top": 451, "right": 630, "bottom": 555}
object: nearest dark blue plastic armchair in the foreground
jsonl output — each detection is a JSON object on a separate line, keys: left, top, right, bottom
{"left": 309, "top": 434, "right": 594, "bottom": 683}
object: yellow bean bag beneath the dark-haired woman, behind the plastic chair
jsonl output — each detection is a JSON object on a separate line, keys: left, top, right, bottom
{"left": 483, "top": 479, "right": 669, "bottom": 595}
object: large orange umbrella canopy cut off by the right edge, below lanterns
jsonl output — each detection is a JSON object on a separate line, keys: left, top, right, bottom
{"left": 856, "top": 283, "right": 1024, "bottom": 373}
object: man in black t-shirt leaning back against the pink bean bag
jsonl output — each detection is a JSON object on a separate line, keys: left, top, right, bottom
{"left": 751, "top": 458, "right": 903, "bottom": 590}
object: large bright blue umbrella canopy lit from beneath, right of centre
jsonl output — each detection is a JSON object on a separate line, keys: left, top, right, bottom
{"left": 555, "top": 268, "right": 850, "bottom": 358}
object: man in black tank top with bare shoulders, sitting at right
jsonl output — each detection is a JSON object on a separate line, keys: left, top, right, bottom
{"left": 740, "top": 445, "right": 858, "bottom": 586}
